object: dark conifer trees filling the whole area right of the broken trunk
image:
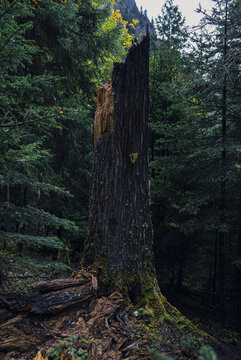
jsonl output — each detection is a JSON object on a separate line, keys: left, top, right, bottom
{"left": 150, "top": 0, "right": 241, "bottom": 327}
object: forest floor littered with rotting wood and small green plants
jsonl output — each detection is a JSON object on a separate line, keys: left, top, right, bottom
{"left": 0, "top": 267, "right": 241, "bottom": 360}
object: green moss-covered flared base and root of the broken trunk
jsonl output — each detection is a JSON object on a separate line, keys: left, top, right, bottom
{"left": 93, "top": 259, "right": 216, "bottom": 351}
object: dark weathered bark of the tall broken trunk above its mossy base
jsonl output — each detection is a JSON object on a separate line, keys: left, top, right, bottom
{"left": 84, "top": 35, "right": 152, "bottom": 276}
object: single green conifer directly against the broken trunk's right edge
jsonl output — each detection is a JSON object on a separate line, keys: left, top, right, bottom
{"left": 150, "top": 0, "right": 196, "bottom": 292}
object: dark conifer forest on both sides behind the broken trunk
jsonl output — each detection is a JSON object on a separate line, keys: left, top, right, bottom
{"left": 0, "top": 0, "right": 241, "bottom": 331}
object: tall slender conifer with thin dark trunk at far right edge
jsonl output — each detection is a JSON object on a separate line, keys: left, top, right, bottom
{"left": 190, "top": 0, "right": 240, "bottom": 324}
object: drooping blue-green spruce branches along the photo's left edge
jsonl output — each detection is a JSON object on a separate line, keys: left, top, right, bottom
{"left": 0, "top": 2, "right": 77, "bottom": 264}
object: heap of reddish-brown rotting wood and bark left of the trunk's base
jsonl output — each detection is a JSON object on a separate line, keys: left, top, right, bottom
{"left": 0, "top": 268, "right": 149, "bottom": 360}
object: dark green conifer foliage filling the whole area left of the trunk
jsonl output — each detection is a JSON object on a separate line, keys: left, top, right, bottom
{"left": 0, "top": 0, "right": 130, "bottom": 278}
